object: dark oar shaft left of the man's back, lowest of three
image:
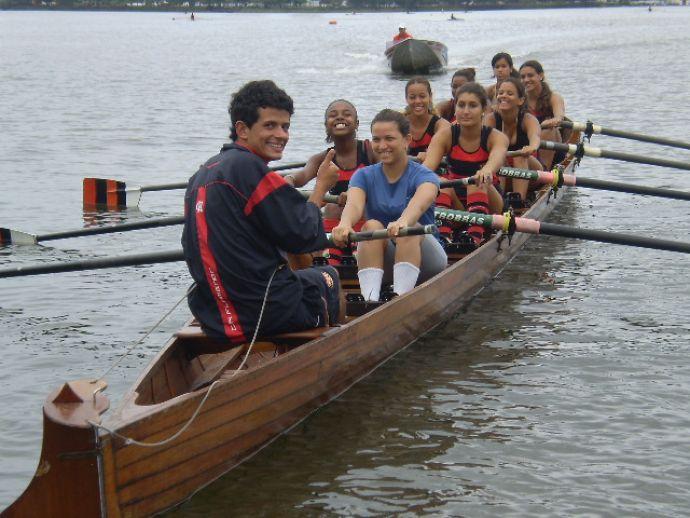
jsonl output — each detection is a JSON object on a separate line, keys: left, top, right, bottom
{"left": 0, "top": 250, "right": 184, "bottom": 278}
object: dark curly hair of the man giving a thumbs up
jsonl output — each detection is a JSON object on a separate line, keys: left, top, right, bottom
{"left": 228, "top": 80, "right": 295, "bottom": 141}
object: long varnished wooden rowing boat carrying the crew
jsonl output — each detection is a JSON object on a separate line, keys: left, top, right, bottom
{"left": 2, "top": 135, "right": 573, "bottom": 517}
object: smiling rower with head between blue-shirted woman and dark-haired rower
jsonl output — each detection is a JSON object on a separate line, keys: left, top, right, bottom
{"left": 405, "top": 77, "right": 450, "bottom": 162}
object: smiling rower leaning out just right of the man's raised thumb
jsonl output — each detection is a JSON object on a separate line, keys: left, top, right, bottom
{"left": 285, "top": 99, "right": 376, "bottom": 264}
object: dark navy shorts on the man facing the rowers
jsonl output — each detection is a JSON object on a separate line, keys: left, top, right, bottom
{"left": 290, "top": 266, "right": 340, "bottom": 331}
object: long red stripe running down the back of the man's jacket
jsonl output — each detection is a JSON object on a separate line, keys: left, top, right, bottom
{"left": 194, "top": 187, "right": 247, "bottom": 343}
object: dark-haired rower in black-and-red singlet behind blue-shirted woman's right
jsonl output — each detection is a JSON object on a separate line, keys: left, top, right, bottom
{"left": 424, "top": 83, "right": 508, "bottom": 245}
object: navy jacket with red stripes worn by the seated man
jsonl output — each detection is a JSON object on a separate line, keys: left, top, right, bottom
{"left": 182, "top": 144, "right": 328, "bottom": 343}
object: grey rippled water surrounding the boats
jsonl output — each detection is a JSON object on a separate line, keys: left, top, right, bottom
{"left": 0, "top": 8, "right": 690, "bottom": 516}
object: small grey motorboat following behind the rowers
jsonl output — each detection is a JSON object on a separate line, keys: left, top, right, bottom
{"left": 385, "top": 38, "right": 448, "bottom": 74}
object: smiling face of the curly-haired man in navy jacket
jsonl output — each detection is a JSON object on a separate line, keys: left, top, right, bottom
{"left": 235, "top": 108, "right": 290, "bottom": 162}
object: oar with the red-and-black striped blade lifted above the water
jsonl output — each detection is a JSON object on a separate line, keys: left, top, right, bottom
{"left": 83, "top": 162, "right": 306, "bottom": 210}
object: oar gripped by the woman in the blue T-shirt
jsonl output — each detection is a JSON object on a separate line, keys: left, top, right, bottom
{"left": 0, "top": 225, "right": 436, "bottom": 278}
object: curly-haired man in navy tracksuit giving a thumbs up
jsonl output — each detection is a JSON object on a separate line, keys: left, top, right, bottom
{"left": 182, "top": 81, "right": 340, "bottom": 343}
